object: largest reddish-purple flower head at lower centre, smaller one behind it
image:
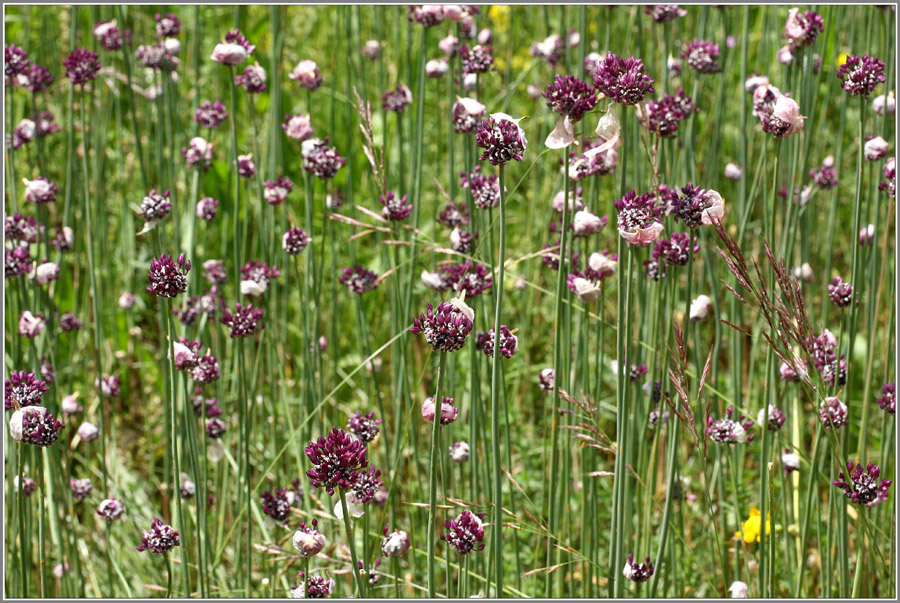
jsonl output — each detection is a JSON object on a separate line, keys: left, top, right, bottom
{"left": 305, "top": 427, "right": 369, "bottom": 494}
